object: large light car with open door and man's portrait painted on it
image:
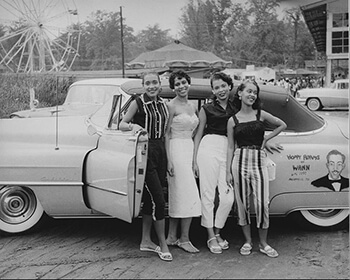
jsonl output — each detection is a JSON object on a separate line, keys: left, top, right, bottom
{"left": 0, "top": 79, "right": 349, "bottom": 233}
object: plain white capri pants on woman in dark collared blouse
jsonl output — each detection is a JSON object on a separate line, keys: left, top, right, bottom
{"left": 197, "top": 134, "right": 234, "bottom": 229}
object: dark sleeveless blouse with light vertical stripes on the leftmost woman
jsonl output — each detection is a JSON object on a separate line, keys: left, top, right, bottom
{"left": 133, "top": 93, "right": 169, "bottom": 139}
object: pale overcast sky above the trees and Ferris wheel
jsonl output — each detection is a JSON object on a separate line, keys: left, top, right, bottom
{"left": 0, "top": 0, "right": 319, "bottom": 39}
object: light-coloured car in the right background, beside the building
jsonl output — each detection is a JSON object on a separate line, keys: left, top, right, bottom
{"left": 296, "top": 79, "right": 349, "bottom": 111}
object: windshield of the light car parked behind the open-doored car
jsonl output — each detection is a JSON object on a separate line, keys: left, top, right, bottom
{"left": 64, "top": 85, "right": 118, "bottom": 105}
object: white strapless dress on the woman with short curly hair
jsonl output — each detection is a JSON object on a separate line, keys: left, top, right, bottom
{"left": 168, "top": 113, "right": 201, "bottom": 218}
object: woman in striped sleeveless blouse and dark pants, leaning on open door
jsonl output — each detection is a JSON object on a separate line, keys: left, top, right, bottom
{"left": 120, "top": 73, "right": 173, "bottom": 261}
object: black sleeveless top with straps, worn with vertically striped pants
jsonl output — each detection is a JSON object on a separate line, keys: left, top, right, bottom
{"left": 232, "top": 110, "right": 265, "bottom": 148}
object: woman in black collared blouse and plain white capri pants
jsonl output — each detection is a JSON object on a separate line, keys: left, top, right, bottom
{"left": 193, "top": 72, "right": 234, "bottom": 254}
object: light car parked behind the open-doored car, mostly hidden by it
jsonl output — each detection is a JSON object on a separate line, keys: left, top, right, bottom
{"left": 9, "top": 78, "right": 134, "bottom": 118}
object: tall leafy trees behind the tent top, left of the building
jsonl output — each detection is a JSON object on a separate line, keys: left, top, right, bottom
{"left": 180, "top": 0, "right": 313, "bottom": 68}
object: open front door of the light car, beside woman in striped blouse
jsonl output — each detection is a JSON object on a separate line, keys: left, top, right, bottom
{"left": 85, "top": 94, "right": 148, "bottom": 222}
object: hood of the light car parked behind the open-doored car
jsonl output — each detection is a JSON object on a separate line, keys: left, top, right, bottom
{"left": 10, "top": 104, "right": 101, "bottom": 118}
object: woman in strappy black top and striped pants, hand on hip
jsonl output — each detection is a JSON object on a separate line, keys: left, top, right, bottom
{"left": 226, "top": 81, "right": 287, "bottom": 257}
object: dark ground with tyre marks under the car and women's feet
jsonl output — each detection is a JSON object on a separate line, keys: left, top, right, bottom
{"left": 0, "top": 214, "right": 349, "bottom": 279}
